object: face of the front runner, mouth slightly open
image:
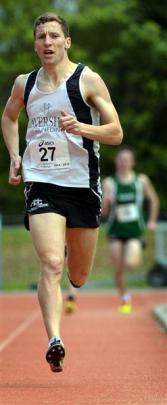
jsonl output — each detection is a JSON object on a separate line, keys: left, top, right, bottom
{"left": 35, "top": 21, "right": 71, "bottom": 65}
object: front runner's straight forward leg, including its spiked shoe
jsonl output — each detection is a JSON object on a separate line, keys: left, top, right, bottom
{"left": 30, "top": 213, "right": 66, "bottom": 371}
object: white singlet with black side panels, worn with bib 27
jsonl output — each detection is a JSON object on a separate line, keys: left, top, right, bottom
{"left": 22, "top": 64, "right": 99, "bottom": 188}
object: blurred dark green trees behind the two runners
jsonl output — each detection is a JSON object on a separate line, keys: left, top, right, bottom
{"left": 0, "top": 0, "right": 167, "bottom": 213}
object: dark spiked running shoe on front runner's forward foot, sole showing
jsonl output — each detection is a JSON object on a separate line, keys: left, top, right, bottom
{"left": 46, "top": 337, "right": 65, "bottom": 373}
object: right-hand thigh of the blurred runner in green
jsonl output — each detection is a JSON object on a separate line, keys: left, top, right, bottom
{"left": 124, "top": 239, "right": 142, "bottom": 269}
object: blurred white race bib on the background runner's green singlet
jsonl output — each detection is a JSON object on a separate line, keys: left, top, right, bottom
{"left": 116, "top": 203, "right": 139, "bottom": 222}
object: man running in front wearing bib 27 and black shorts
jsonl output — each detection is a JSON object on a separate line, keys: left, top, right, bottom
{"left": 2, "top": 13, "right": 123, "bottom": 372}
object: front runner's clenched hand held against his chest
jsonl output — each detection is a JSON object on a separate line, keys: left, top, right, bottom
{"left": 59, "top": 111, "right": 82, "bottom": 135}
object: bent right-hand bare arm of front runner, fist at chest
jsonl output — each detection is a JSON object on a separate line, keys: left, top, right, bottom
{"left": 60, "top": 70, "right": 123, "bottom": 145}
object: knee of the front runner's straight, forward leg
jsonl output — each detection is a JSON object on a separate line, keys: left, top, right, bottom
{"left": 40, "top": 253, "right": 64, "bottom": 274}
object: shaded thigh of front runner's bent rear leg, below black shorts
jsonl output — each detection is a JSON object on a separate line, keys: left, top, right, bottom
{"left": 66, "top": 228, "right": 98, "bottom": 275}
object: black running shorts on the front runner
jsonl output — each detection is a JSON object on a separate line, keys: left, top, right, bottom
{"left": 25, "top": 182, "right": 101, "bottom": 229}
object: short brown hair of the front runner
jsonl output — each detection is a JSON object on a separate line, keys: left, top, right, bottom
{"left": 34, "top": 12, "right": 70, "bottom": 38}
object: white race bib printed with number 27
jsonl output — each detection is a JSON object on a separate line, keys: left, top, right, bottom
{"left": 29, "top": 138, "right": 70, "bottom": 170}
